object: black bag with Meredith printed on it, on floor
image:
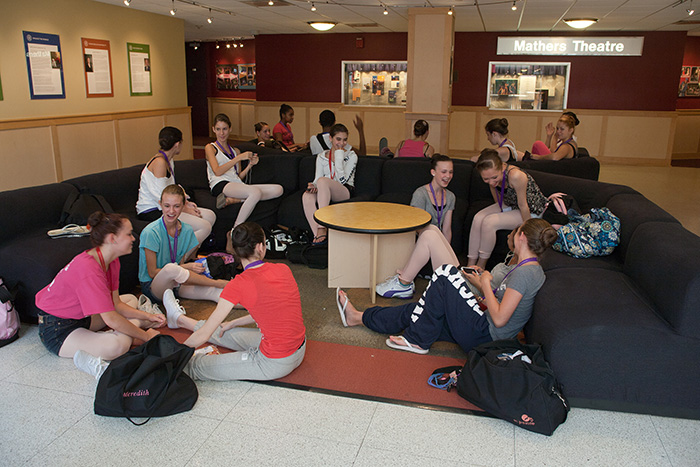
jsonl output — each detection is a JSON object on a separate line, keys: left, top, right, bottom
{"left": 95, "top": 334, "right": 199, "bottom": 425}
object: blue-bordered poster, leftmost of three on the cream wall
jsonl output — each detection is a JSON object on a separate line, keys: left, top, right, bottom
{"left": 22, "top": 31, "right": 66, "bottom": 99}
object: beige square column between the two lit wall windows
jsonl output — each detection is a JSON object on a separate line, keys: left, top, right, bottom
{"left": 406, "top": 8, "right": 454, "bottom": 154}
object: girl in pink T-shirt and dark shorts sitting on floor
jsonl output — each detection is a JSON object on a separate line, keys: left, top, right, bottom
{"left": 36, "top": 212, "right": 165, "bottom": 360}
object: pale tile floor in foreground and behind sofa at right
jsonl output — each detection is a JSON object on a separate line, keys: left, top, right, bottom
{"left": 5, "top": 166, "right": 700, "bottom": 467}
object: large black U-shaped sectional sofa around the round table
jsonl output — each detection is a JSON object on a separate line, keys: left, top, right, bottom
{"left": 0, "top": 145, "right": 700, "bottom": 418}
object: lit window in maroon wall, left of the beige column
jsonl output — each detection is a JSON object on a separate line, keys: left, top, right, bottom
{"left": 341, "top": 61, "right": 408, "bottom": 107}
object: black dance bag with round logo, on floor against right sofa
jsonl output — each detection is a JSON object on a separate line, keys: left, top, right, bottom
{"left": 457, "top": 339, "right": 569, "bottom": 436}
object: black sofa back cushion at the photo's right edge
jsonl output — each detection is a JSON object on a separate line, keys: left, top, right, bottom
{"left": 624, "top": 222, "right": 700, "bottom": 339}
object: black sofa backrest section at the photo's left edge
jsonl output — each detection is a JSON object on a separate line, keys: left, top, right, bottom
{"left": 0, "top": 183, "right": 78, "bottom": 244}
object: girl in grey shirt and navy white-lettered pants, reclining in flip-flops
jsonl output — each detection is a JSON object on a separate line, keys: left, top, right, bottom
{"left": 337, "top": 219, "right": 557, "bottom": 354}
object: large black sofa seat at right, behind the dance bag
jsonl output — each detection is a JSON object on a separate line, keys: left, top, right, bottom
{"left": 525, "top": 268, "right": 700, "bottom": 409}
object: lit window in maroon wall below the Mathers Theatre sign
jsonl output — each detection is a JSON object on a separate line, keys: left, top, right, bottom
{"left": 486, "top": 62, "right": 571, "bottom": 110}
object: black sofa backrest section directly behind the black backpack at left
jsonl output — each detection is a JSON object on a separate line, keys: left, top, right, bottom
{"left": 63, "top": 164, "right": 144, "bottom": 217}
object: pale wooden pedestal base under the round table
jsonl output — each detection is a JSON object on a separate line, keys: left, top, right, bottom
{"left": 328, "top": 229, "right": 416, "bottom": 303}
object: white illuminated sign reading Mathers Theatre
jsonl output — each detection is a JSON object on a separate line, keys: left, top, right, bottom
{"left": 496, "top": 36, "right": 644, "bottom": 56}
